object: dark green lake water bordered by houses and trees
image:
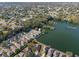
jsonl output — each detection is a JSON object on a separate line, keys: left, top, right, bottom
{"left": 38, "top": 22, "right": 79, "bottom": 55}
